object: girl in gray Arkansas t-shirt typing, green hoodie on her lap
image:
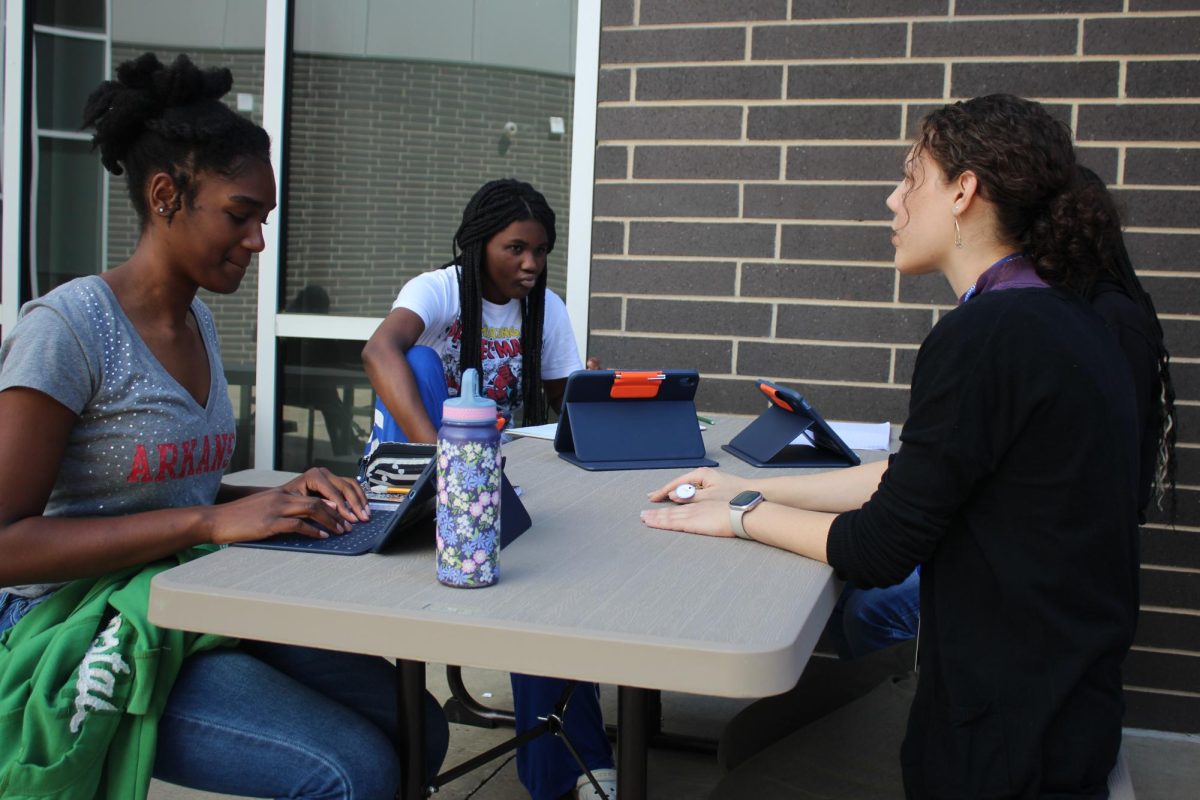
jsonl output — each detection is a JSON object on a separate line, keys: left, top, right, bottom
{"left": 0, "top": 53, "right": 449, "bottom": 799}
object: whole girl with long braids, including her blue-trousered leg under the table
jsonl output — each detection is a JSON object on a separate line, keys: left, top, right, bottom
{"left": 362, "top": 179, "right": 616, "bottom": 800}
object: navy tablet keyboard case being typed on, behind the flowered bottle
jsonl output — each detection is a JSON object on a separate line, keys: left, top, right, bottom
{"left": 235, "top": 458, "right": 533, "bottom": 555}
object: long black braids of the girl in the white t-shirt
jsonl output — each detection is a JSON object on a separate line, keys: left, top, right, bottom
{"left": 445, "top": 178, "right": 557, "bottom": 425}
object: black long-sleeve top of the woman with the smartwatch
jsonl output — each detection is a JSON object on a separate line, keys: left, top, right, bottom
{"left": 828, "top": 289, "right": 1138, "bottom": 798}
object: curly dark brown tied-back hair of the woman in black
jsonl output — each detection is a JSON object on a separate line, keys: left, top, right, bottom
{"left": 916, "top": 95, "right": 1121, "bottom": 295}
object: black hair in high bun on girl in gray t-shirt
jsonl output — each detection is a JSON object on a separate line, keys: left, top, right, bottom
{"left": 82, "top": 53, "right": 271, "bottom": 227}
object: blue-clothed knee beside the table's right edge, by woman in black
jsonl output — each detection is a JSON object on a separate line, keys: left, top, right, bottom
{"left": 826, "top": 572, "right": 920, "bottom": 658}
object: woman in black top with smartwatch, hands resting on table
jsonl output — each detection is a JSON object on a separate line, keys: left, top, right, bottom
{"left": 642, "top": 95, "right": 1156, "bottom": 798}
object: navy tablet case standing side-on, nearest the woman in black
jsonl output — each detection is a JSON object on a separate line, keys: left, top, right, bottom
{"left": 721, "top": 380, "right": 862, "bottom": 467}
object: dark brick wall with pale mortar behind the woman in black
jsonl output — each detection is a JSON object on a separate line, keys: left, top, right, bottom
{"left": 589, "top": 0, "right": 1200, "bottom": 732}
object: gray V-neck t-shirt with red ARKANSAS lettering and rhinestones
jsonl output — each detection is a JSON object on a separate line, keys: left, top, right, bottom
{"left": 0, "top": 276, "right": 234, "bottom": 596}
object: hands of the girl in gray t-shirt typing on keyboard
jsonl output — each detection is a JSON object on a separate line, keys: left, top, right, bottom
{"left": 209, "top": 467, "right": 371, "bottom": 545}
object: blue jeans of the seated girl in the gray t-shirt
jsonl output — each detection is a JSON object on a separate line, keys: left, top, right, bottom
{"left": 0, "top": 595, "right": 449, "bottom": 800}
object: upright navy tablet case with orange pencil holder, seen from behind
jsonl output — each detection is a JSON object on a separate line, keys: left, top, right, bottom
{"left": 554, "top": 369, "right": 716, "bottom": 470}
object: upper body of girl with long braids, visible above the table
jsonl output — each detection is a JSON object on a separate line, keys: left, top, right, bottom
{"left": 362, "top": 179, "right": 581, "bottom": 449}
